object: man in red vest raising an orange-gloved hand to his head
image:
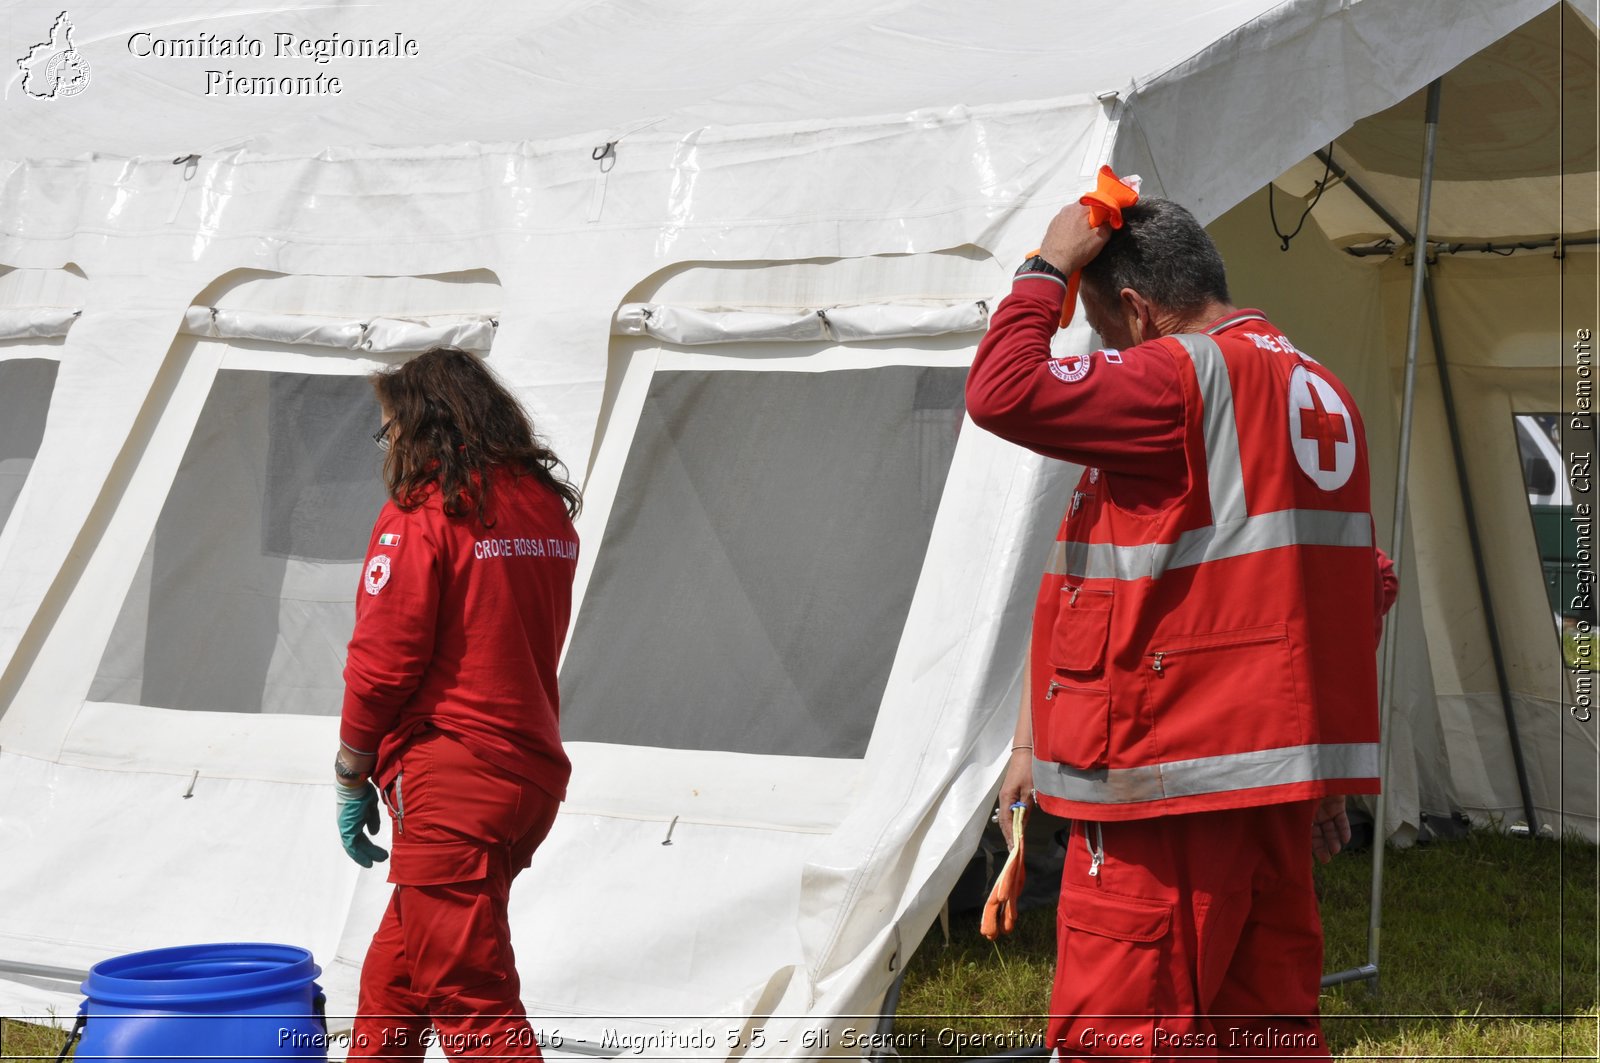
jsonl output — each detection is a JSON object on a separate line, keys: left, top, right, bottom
{"left": 966, "top": 200, "right": 1394, "bottom": 1058}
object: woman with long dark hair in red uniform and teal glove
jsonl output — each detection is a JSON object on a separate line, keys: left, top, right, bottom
{"left": 334, "top": 347, "right": 581, "bottom": 1060}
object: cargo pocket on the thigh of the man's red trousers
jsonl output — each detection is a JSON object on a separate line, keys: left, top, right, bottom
{"left": 1050, "top": 885, "right": 1173, "bottom": 1055}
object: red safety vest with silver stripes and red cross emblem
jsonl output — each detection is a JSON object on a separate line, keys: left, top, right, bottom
{"left": 1032, "top": 312, "right": 1379, "bottom": 820}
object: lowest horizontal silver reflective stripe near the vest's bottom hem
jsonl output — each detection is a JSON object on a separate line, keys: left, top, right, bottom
{"left": 1034, "top": 743, "right": 1378, "bottom": 805}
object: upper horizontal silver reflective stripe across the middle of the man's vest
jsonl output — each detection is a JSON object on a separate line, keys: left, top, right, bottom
{"left": 1046, "top": 509, "right": 1373, "bottom": 580}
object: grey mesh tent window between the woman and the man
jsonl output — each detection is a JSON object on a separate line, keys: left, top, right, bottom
{"left": 562, "top": 367, "right": 966, "bottom": 757}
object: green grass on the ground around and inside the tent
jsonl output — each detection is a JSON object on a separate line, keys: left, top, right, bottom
{"left": 0, "top": 832, "right": 1600, "bottom": 1060}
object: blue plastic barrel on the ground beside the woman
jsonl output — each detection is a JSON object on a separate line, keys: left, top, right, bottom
{"left": 74, "top": 943, "right": 328, "bottom": 1063}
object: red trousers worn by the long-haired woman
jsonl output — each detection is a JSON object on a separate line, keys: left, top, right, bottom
{"left": 349, "top": 732, "right": 560, "bottom": 1061}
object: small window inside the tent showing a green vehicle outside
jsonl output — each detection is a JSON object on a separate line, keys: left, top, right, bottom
{"left": 1514, "top": 413, "right": 1600, "bottom": 669}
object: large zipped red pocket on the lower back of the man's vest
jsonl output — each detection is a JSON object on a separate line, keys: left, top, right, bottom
{"left": 1144, "top": 624, "right": 1306, "bottom": 760}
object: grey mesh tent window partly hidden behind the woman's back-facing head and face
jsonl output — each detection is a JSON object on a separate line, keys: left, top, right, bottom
{"left": 90, "top": 370, "right": 384, "bottom": 716}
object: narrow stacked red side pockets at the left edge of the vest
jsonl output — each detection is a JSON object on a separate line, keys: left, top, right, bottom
{"left": 1034, "top": 586, "right": 1112, "bottom": 770}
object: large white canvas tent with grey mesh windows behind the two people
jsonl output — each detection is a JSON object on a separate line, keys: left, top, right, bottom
{"left": 0, "top": 0, "right": 1597, "bottom": 1057}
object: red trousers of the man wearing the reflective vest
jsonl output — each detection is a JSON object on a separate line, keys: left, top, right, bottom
{"left": 1048, "top": 802, "right": 1328, "bottom": 1061}
